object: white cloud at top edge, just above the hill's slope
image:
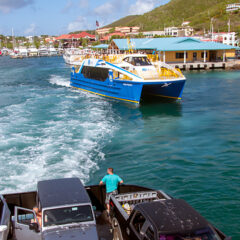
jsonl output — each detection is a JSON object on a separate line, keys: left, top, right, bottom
{"left": 129, "top": 0, "right": 160, "bottom": 15}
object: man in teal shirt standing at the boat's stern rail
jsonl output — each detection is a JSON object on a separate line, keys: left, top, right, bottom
{"left": 99, "top": 168, "right": 123, "bottom": 213}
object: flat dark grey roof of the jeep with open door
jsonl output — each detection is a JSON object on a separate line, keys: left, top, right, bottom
{"left": 37, "top": 178, "right": 91, "bottom": 208}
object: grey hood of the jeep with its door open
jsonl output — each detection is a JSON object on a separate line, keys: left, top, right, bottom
{"left": 42, "top": 224, "right": 98, "bottom": 240}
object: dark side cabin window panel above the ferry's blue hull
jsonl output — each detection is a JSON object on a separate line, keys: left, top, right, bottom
{"left": 81, "top": 66, "right": 108, "bottom": 82}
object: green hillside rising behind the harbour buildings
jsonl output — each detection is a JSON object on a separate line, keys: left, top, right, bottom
{"left": 108, "top": 0, "right": 240, "bottom": 32}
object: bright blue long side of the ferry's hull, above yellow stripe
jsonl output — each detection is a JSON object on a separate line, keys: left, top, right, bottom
{"left": 70, "top": 73, "right": 143, "bottom": 104}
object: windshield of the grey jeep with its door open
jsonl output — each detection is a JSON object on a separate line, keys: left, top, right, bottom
{"left": 43, "top": 205, "right": 93, "bottom": 227}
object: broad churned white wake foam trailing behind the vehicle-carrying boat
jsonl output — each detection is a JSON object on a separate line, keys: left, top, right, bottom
{"left": 0, "top": 87, "right": 118, "bottom": 192}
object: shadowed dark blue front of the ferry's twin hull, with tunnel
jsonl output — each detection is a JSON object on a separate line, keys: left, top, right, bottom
{"left": 142, "top": 80, "right": 185, "bottom": 99}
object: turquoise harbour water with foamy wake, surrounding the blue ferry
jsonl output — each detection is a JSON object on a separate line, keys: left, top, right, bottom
{"left": 0, "top": 57, "right": 240, "bottom": 239}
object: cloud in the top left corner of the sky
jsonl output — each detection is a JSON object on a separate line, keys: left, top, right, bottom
{"left": 0, "top": 0, "right": 34, "bottom": 13}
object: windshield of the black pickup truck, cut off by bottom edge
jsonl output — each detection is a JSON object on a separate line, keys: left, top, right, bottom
{"left": 159, "top": 228, "right": 220, "bottom": 240}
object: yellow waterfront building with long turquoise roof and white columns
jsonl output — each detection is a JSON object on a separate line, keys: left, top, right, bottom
{"left": 108, "top": 37, "right": 237, "bottom": 63}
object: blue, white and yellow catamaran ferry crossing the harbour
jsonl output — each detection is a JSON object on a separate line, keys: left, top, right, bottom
{"left": 70, "top": 54, "right": 186, "bottom": 104}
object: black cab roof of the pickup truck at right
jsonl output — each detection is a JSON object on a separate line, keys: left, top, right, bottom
{"left": 136, "top": 199, "right": 208, "bottom": 234}
